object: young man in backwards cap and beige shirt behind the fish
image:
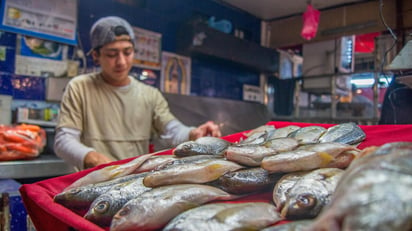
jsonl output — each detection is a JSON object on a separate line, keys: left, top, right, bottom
{"left": 54, "top": 17, "right": 221, "bottom": 169}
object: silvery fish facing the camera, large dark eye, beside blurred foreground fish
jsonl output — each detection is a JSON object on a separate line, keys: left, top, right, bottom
{"left": 273, "top": 168, "right": 344, "bottom": 220}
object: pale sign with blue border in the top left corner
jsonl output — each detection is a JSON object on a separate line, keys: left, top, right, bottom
{"left": 0, "top": 0, "right": 77, "bottom": 45}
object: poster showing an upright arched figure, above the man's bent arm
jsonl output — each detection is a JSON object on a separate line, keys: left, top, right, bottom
{"left": 160, "top": 52, "right": 191, "bottom": 95}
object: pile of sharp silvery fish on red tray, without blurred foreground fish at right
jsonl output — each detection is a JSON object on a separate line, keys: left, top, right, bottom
{"left": 54, "top": 123, "right": 406, "bottom": 230}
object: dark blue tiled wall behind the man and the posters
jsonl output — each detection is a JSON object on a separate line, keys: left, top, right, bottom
{"left": 0, "top": 0, "right": 260, "bottom": 111}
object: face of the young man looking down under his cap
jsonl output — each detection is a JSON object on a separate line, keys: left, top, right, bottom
{"left": 93, "top": 40, "right": 134, "bottom": 86}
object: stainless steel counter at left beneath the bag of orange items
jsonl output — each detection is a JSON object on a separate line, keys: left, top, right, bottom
{"left": 0, "top": 154, "right": 75, "bottom": 179}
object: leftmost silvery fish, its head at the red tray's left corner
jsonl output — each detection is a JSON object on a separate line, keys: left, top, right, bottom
{"left": 53, "top": 174, "right": 146, "bottom": 209}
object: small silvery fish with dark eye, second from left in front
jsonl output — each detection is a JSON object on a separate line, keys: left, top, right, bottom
{"left": 84, "top": 173, "right": 151, "bottom": 227}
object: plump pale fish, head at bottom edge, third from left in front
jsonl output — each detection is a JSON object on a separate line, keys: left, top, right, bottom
{"left": 110, "top": 184, "right": 238, "bottom": 231}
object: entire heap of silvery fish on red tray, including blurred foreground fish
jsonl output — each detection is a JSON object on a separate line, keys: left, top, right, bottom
{"left": 54, "top": 123, "right": 412, "bottom": 231}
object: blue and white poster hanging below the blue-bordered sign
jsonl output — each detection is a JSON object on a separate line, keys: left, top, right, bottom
{"left": 15, "top": 35, "right": 69, "bottom": 77}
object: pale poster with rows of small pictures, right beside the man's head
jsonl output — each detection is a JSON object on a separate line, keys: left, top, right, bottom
{"left": 133, "top": 27, "right": 162, "bottom": 70}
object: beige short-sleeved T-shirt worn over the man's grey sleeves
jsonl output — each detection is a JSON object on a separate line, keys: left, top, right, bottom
{"left": 56, "top": 73, "right": 175, "bottom": 164}
